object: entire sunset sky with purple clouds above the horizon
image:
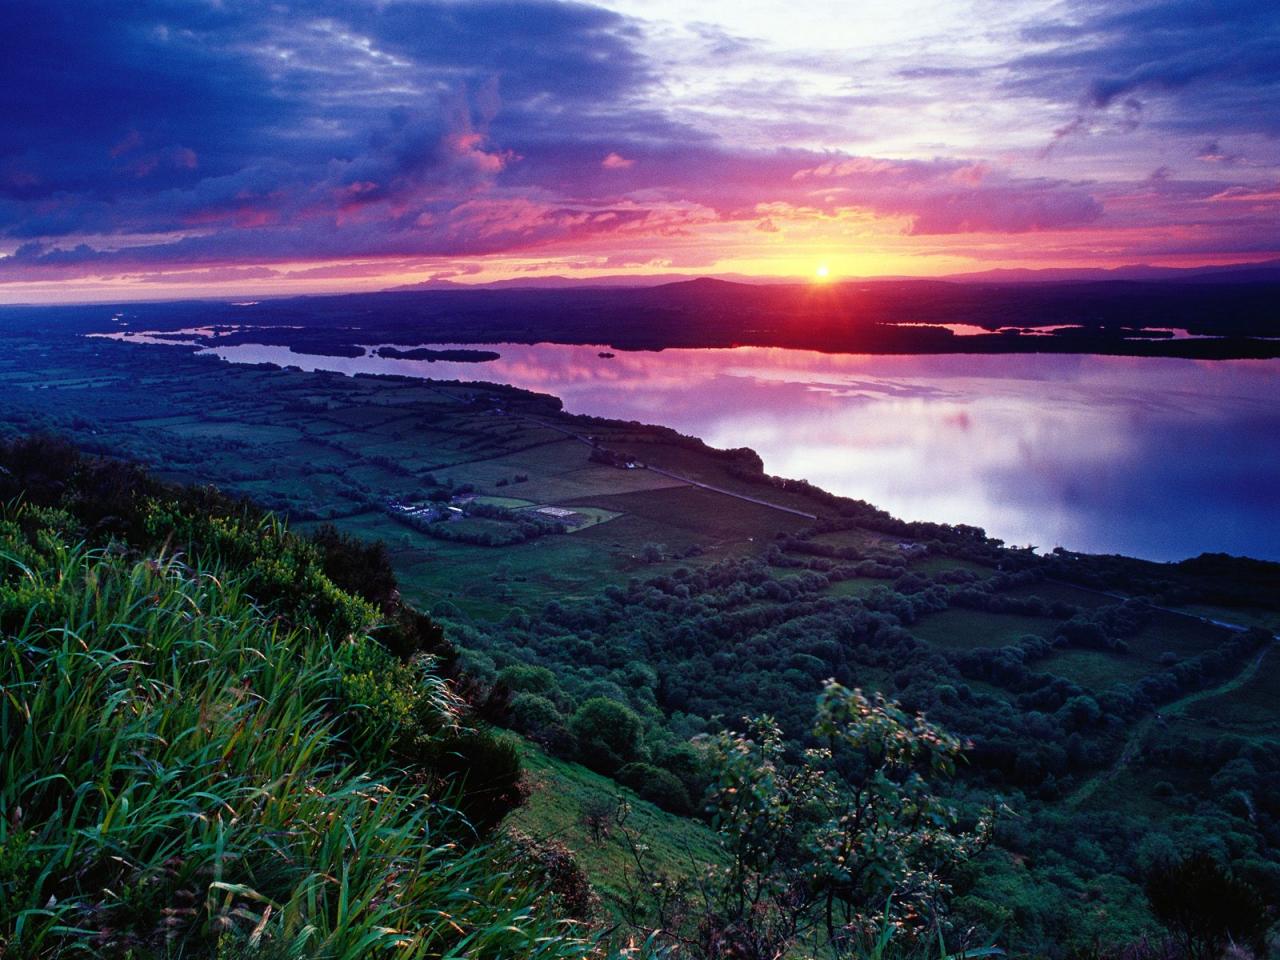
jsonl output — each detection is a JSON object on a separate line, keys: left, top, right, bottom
{"left": 0, "top": 0, "right": 1280, "bottom": 302}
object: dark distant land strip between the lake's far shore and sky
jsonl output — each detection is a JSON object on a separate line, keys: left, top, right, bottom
{"left": 17, "top": 273, "right": 1280, "bottom": 358}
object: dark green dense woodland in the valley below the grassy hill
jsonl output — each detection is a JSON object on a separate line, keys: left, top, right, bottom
{"left": 451, "top": 537, "right": 1280, "bottom": 948}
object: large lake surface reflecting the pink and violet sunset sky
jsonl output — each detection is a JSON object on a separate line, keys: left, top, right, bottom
{"left": 189, "top": 344, "right": 1280, "bottom": 559}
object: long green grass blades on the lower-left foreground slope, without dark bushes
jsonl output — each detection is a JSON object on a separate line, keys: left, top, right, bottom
{"left": 0, "top": 507, "right": 591, "bottom": 960}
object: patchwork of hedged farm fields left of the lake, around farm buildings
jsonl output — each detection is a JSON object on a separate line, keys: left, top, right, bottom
{"left": 0, "top": 338, "right": 819, "bottom": 620}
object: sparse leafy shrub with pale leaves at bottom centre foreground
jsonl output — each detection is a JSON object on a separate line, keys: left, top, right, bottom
{"left": 622, "top": 681, "right": 992, "bottom": 959}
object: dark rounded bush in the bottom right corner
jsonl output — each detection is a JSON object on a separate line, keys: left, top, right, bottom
{"left": 1147, "top": 852, "right": 1271, "bottom": 960}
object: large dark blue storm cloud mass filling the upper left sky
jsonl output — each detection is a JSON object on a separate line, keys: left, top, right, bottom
{"left": 0, "top": 0, "right": 649, "bottom": 244}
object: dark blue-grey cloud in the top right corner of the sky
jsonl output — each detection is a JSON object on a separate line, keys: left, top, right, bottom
{"left": 1009, "top": 0, "right": 1280, "bottom": 136}
